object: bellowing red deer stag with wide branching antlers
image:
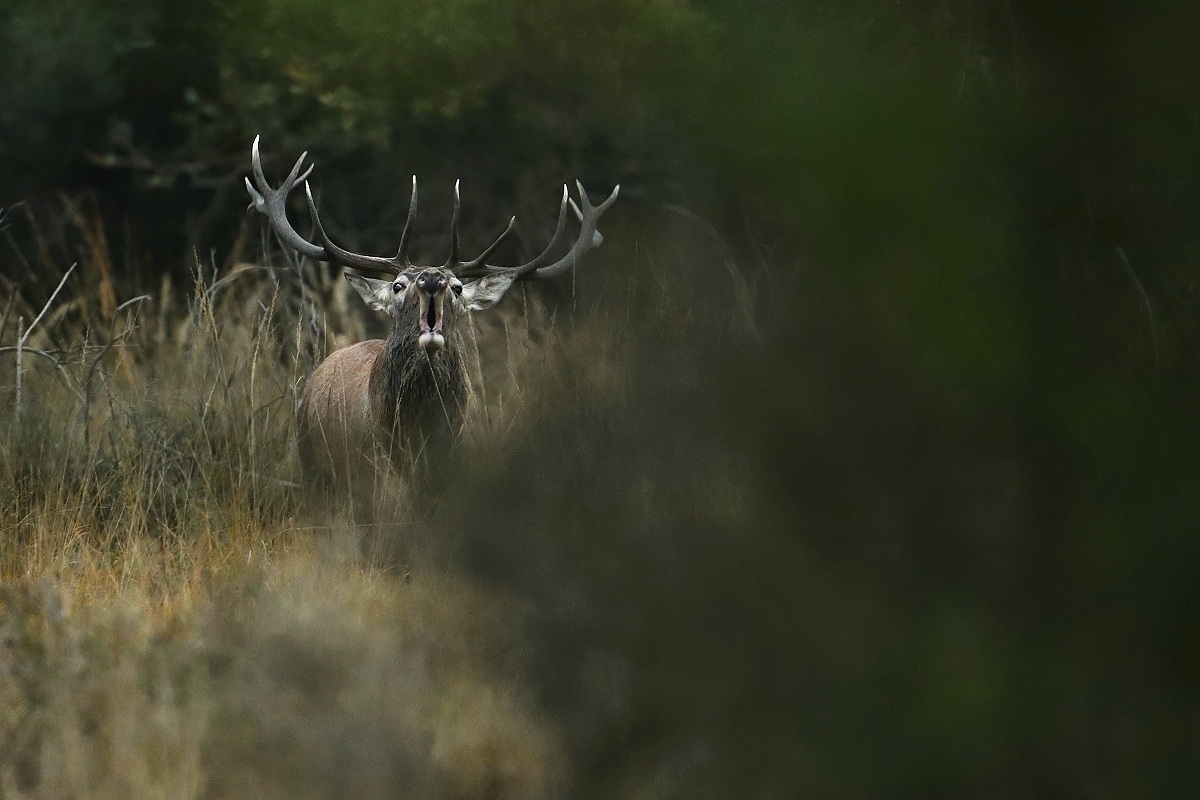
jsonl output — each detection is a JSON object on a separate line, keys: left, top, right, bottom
{"left": 246, "top": 137, "right": 620, "bottom": 494}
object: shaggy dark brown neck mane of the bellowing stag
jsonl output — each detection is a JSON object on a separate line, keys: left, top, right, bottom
{"left": 371, "top": 303, "right": 467, "bottom": 448}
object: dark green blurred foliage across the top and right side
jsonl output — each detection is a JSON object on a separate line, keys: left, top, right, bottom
{"left": 0, "top": 0, "right": 1200, "bottom": 798}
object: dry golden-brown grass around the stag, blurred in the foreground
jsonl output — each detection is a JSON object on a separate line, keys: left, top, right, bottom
{"left": 0, "top": 203, "right": 600, "bottom": 798}
